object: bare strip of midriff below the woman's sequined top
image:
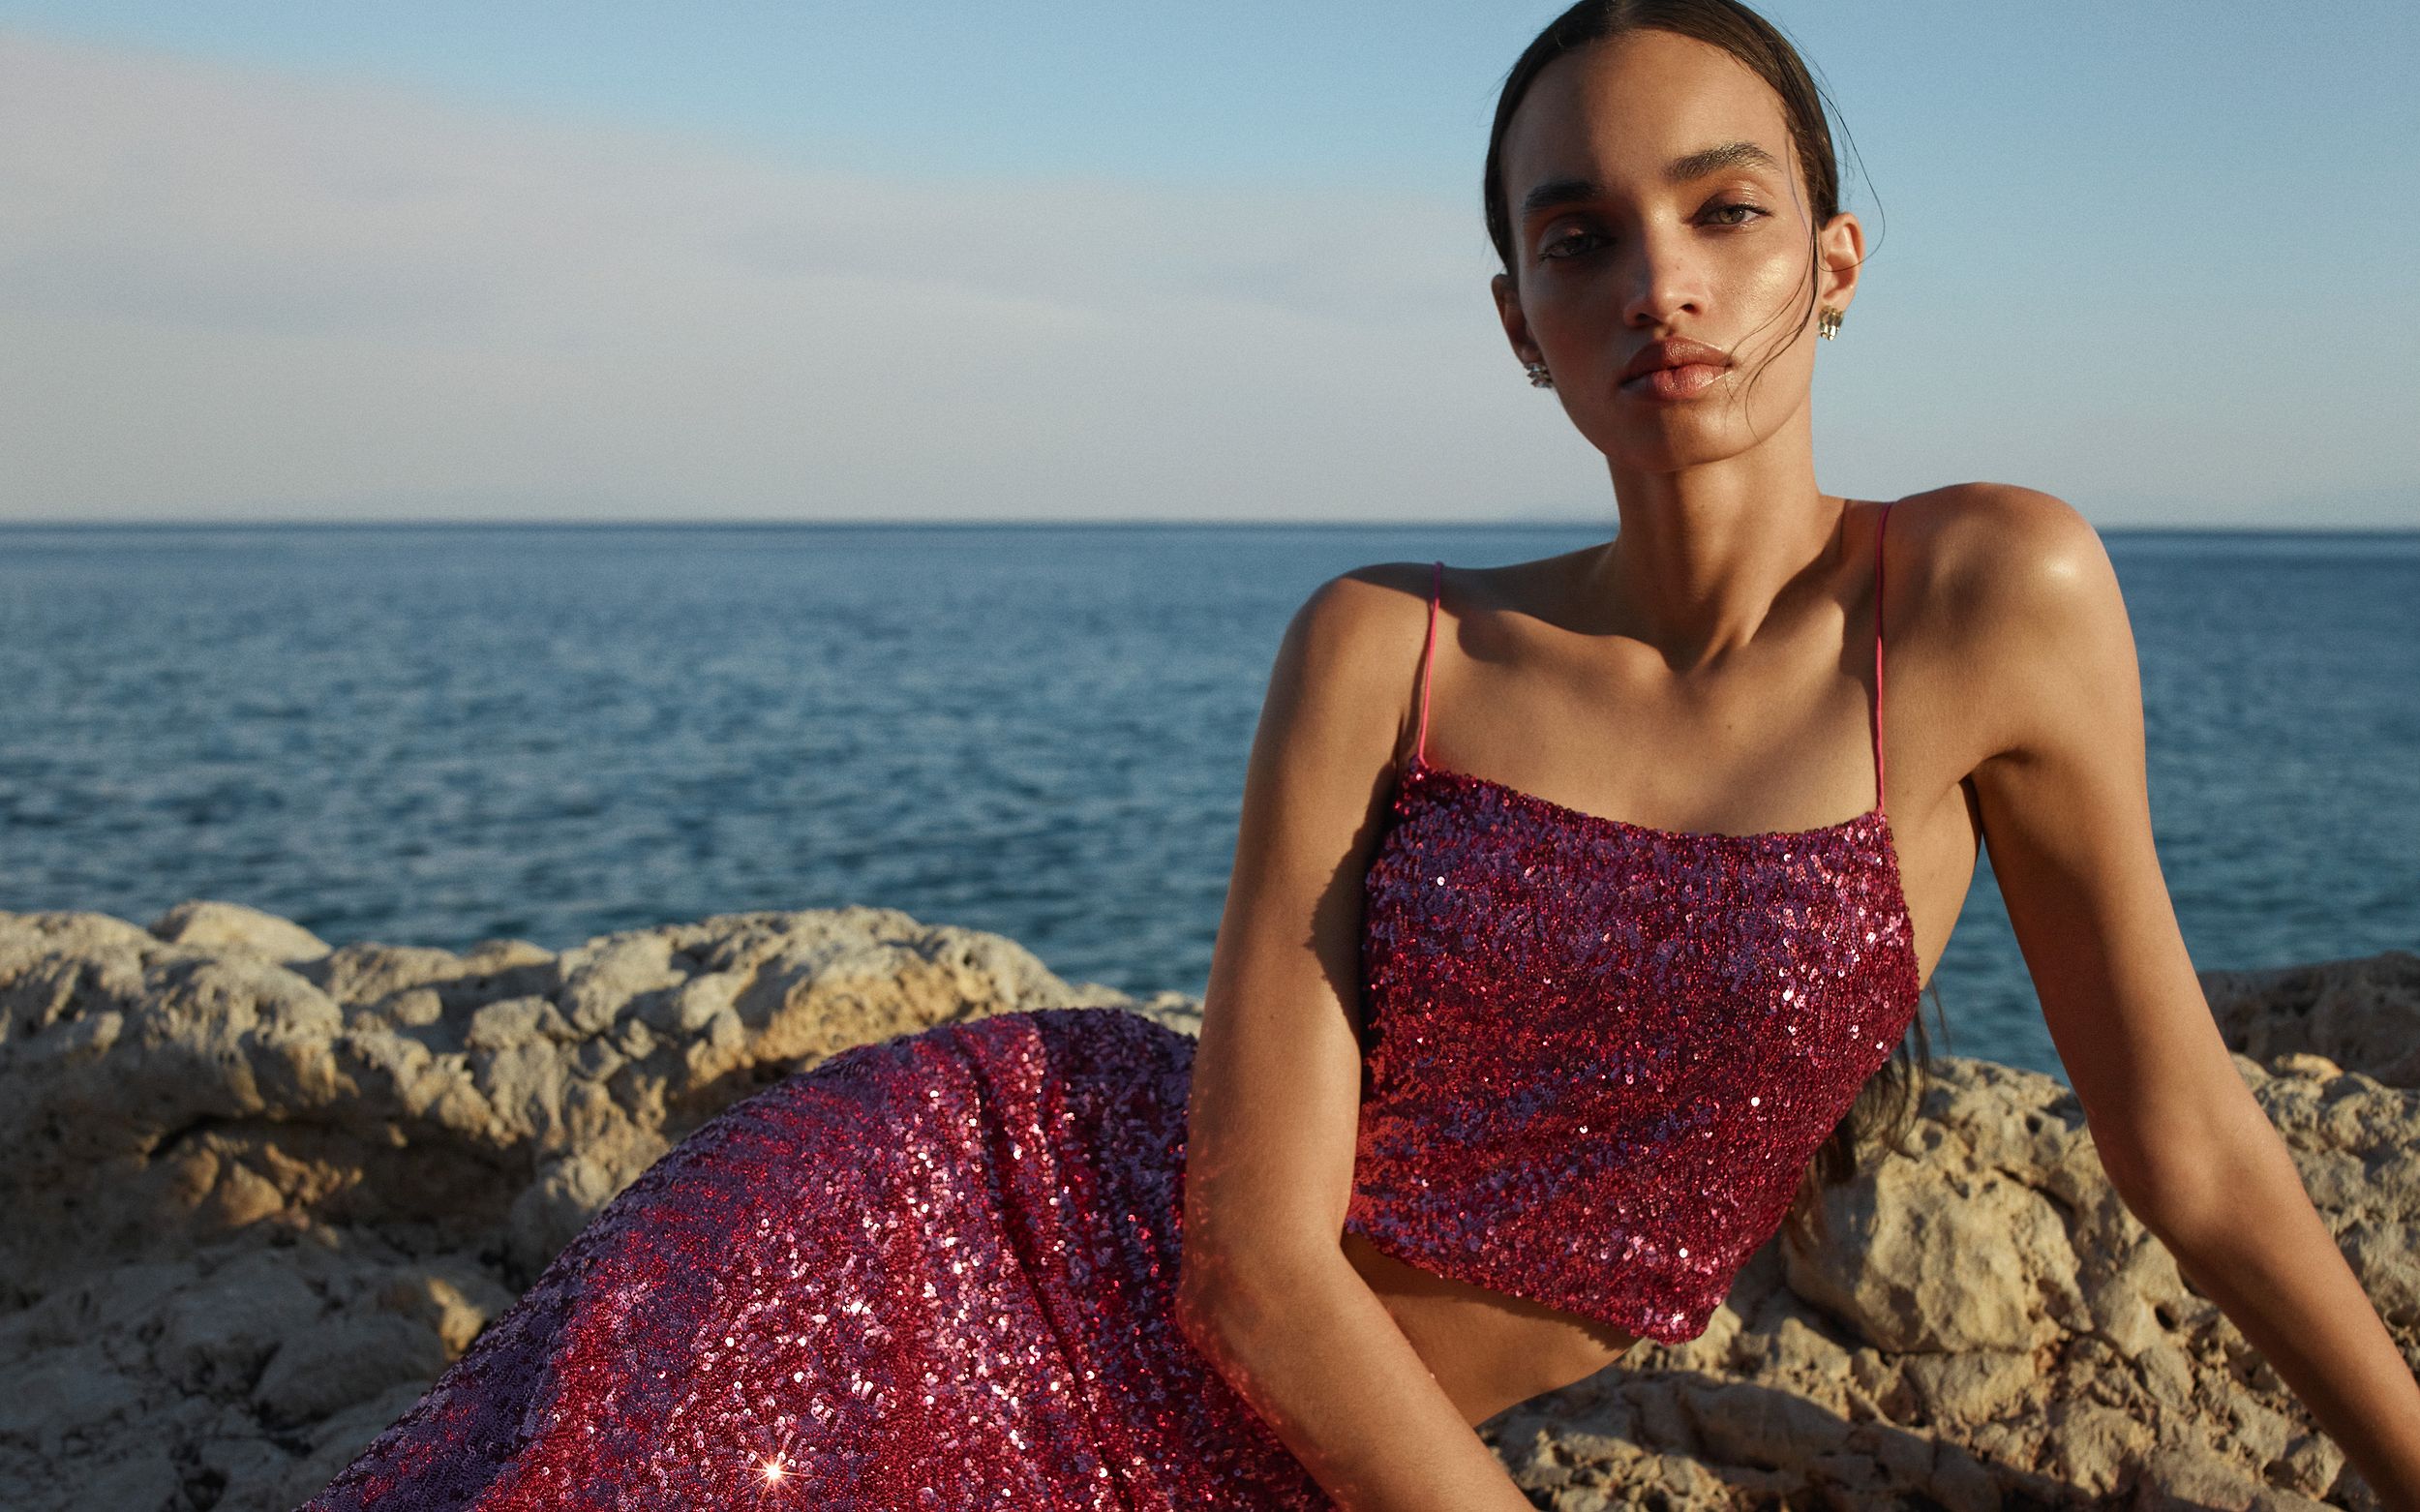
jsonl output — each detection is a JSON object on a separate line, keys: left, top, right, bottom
{"left": 1344, "top": 1231, "right": 1639, "bottom": 1428}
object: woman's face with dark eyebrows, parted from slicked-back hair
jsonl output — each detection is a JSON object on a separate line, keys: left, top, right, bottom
{"left": 1496, "top": 31, "right": 1863, "bottom": 471}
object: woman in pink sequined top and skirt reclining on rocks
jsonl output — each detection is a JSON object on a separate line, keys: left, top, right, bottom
{"left": 313, "top": 0, "right": 2420, "bottom": 1512}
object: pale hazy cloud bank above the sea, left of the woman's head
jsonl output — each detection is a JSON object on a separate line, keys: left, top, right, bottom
{"left": 0, "top": 34, "right": 1602, "bottom": 518}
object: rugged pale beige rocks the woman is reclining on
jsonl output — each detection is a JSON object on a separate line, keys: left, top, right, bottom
{"left": 0, "top": 902, "right": 2420, "bottom": 1512}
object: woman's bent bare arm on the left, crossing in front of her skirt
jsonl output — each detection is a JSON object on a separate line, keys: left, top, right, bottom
{"left": 1179, "top": 568, "right": 1529, "bottom": 1512}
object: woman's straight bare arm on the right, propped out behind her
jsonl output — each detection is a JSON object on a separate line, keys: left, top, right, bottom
{"left": 1965, "top": 489, "right": 2420, "bottom": 1507}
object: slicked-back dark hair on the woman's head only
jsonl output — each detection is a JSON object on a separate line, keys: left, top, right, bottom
{"left": 1481, "top": 0, "right": 1854, "bottom": 408}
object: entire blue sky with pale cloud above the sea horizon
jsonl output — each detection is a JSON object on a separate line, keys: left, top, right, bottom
{"left": 0, "top": 0, "right": 2420, "bottom": 529}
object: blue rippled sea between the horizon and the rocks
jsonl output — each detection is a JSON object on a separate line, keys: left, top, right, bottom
{"left": 0, "top": 525, "right": 2420, "bottom": 1074}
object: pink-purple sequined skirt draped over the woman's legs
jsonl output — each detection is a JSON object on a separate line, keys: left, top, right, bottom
{"left": 308, "top": 1009, "right": 1334, "bottom": 1512}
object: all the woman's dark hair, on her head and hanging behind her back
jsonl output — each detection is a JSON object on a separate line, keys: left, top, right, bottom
{"left": 1481, "top": 0, "right": 1917, "bottom": 1241}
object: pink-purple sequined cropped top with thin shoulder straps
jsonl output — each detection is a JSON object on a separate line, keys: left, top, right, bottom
{"left": 1346, "top": 505, "right": 1921, "bottom": 1343}
